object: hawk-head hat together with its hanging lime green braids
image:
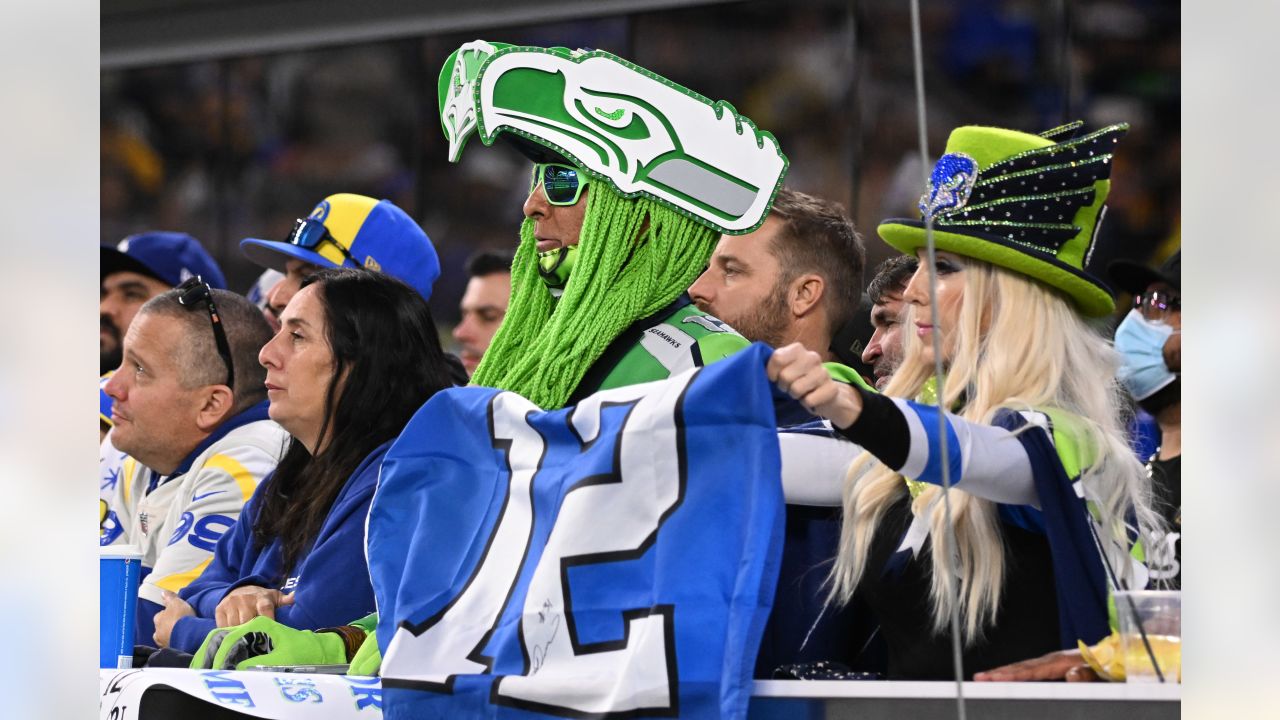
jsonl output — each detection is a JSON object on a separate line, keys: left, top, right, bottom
{"left": 438, "top": 40, "right": 787, "bottom": 409}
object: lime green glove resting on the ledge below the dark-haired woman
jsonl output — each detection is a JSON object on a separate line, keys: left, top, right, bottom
{"left": 191, "top": 615, "right": 348, "bottom": 671}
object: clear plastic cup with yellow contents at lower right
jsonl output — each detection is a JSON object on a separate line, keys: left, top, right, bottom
{"left": 1115, "top": 591, "right": 1183, "bottom": 683}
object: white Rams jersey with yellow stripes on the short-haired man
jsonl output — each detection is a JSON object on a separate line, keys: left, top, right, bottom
{"left": 100, "top": 412, "right": 288, "bottom": 605}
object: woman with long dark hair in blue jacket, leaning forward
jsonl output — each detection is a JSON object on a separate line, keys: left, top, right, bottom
{"left": 156, "top": 269, "right": 452, "bottom": 652}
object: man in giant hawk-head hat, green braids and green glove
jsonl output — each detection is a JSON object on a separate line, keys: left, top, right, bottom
{"left": 186, "top": 41, "right": 787, "bottom": 674}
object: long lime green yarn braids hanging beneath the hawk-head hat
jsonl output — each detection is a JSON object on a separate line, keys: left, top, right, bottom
{"left": 471, "top": 183, "right": 718, "bottom": 409}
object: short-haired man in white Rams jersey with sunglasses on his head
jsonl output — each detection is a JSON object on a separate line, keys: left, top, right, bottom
{"left": 101, "top": 277, "right": 287, "bottom": 646}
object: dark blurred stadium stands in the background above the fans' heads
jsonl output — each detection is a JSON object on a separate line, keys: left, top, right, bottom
{"left": 100, "top": 0, "right": 1181, "bottom": 333}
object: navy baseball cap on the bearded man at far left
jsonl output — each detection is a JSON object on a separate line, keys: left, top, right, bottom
{"left": 99, "top": 232, "right": 227, "bottom": 290}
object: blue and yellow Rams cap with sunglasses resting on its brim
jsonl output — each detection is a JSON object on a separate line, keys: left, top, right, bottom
{"left": 241, "top": 192, "right": 440, "bottom": 300}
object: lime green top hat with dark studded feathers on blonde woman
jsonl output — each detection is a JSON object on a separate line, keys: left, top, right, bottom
{"left": 877, "top": 122, "right": 1129, "bottom": 316}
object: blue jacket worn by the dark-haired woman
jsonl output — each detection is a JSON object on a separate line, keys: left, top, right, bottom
{"left": 169, "top": 442, "right": 390, "bottom": 652}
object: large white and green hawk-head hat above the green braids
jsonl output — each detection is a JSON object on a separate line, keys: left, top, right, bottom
{"left": 439, "top": 40, "right": 787, "bottom": 234}
